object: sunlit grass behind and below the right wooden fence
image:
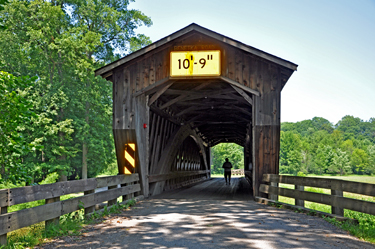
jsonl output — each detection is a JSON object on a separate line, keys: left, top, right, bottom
{"left": 279, "top": 175, "right": 375, "bottom": 243}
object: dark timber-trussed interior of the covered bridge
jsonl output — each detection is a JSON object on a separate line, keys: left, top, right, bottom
{"left": 147, "top": 79, "right": 257, "bottom": 194}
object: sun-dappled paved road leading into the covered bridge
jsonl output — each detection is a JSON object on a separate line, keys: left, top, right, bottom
{"left": 44, "top": 178, "right": 375, "bottom": 249}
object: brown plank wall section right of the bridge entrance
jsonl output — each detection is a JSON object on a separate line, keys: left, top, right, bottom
{"left": 253, "top": 61, "right": 281, "bottom": 197}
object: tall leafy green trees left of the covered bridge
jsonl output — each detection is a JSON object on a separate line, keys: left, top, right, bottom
{"left": 0, "top": 0, "right": 152, "bottom": 184}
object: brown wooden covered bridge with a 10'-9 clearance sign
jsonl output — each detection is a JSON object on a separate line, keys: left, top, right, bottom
{"left": 96, "top": 24, "right": 297, "bottom": 196}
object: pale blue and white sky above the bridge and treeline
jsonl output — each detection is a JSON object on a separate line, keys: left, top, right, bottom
{"left": 129, "top": 0, "right": 375, "bottom": 125}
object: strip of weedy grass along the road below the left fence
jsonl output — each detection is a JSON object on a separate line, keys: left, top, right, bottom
{"left": 0, "top": 199, "right": 135, "bottom": 249}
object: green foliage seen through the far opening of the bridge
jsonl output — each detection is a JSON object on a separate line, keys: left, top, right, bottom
{"left": 212, "top": 143, "right": 244, "bottom": 174}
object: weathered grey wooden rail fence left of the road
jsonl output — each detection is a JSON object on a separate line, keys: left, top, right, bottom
{"left": 0, "top": 174, "right": 141, "bottom": 245}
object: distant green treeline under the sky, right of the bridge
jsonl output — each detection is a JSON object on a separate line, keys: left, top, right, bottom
{"left": 280, "top": 116, "right": 375, "bottom": 175}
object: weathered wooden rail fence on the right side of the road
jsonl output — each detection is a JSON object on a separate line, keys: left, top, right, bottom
{"left": 259, "top": 174, "right": 375, "bottom": 216}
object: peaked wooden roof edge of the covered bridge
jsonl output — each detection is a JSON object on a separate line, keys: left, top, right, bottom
{"left": 95, "top": 23, "right": 298, "bottom": 78}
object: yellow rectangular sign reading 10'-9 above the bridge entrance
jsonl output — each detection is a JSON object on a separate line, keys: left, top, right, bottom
{"left": 170, "top": 50, "right": 220, "bottom": 76}
